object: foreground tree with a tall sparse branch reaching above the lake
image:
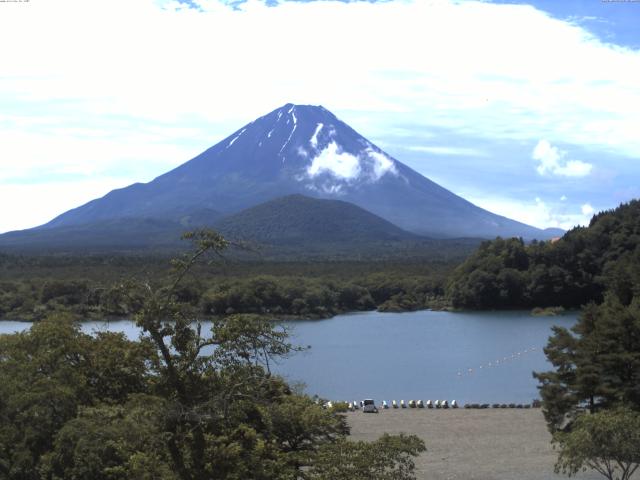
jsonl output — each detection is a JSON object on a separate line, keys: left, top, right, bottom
{"left": 119, "top": 231, "right": 356, "bottom": 480}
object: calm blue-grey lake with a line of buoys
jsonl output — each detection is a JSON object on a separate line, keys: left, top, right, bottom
{"left": 0, "top": 311, "right": 577, "bottom": 403}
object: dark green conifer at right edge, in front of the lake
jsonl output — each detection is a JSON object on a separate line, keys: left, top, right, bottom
{"left": 534, "top": 296, "right": 640, "bottom": 430}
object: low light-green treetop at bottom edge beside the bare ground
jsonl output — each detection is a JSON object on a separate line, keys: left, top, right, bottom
{"left": 308, "top": 434, "right": 426, "bottom": 480}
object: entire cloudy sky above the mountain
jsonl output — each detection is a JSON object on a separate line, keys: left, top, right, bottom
{"left": 0, "top": 0, "right": 640, "bottom": 232}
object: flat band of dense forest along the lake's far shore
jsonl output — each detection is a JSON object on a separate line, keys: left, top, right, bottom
{"left": 0, "top": 251, "right": 460, "bottom": 320}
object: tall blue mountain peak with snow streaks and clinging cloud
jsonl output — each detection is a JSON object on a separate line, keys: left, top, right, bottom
{"left": 15, "top": 104, "right": 557, "bottom": 239}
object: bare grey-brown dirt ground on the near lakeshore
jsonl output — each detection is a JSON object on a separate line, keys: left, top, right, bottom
{"left": 347, "top": 409, "right": 603, "bottom": 480}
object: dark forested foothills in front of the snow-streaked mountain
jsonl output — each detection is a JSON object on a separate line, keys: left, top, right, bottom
{"left": 0, "top": 195, "right": 480, "bottom": 260}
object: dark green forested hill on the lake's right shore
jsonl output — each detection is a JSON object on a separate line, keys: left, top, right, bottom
{"left": 447, "top": 200, "right": 640, "bottom": 309}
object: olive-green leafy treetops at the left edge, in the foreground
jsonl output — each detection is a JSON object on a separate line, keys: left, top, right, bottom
{"left": 0, "top": 315, "right": 154, "bottom": 479}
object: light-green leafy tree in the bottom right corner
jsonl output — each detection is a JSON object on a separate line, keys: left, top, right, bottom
{"left": 553, "top": 409, "right": 640, "bottom": 480}
